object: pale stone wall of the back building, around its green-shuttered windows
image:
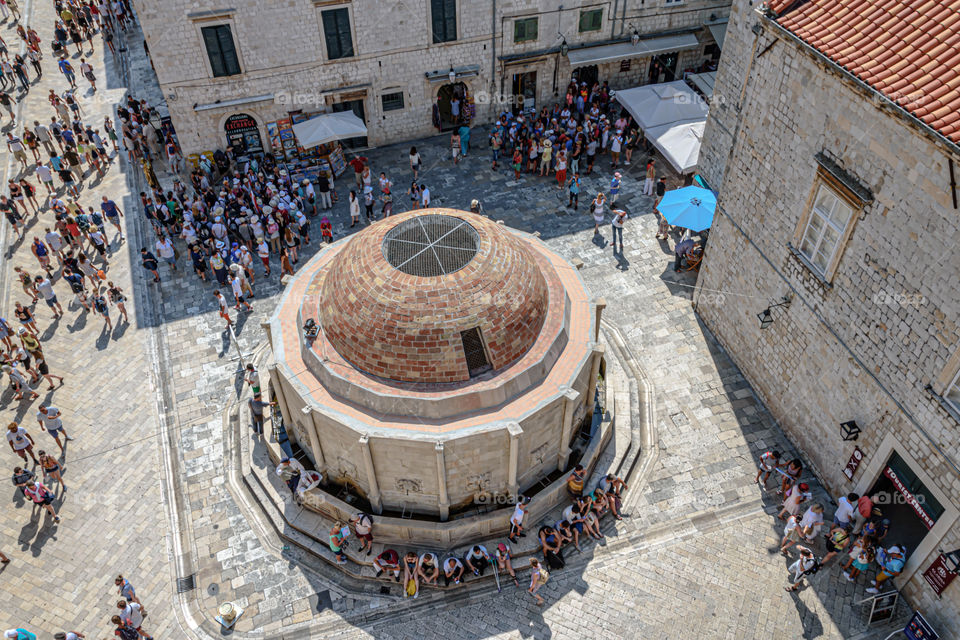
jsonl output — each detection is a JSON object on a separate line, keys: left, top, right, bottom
{"left": 134, "top": 0, "right": 728, "bottom": 153}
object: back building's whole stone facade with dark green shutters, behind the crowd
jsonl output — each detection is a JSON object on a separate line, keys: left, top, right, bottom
{"left": 127, "top": 0, "right": 729, "bottom": 154}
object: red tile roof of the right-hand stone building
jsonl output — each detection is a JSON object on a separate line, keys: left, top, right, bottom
{"left": 767, "top": 0, "right": 960, "bottom": 143}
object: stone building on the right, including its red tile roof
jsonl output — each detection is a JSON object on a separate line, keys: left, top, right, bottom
{"left": 694, "top": 0, "right": 960, "bottom": 637}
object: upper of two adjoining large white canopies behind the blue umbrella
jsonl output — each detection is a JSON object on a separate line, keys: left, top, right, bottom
{"left": 615, "top": 80, "right": 707, "bottom": 131}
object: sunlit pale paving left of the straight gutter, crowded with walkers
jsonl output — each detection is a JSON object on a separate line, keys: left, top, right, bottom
{"left": 0, "top": 1, "right": 178, "bottom": 638}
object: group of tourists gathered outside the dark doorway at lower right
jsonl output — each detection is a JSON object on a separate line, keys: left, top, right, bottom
{"left": 756, "top": 451, "right": 907, "bottom": 594}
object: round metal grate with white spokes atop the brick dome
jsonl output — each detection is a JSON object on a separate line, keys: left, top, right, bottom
{"left": 383, "top": 213, "right": 480, "bottom": 278}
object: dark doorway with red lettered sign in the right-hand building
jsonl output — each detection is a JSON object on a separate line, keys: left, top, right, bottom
{"left": 867, "top": 452, "right": 944, "bottom": 555}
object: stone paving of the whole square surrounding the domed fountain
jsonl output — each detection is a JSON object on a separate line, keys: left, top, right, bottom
{"left": 0, "top": 4, "right": 904, "bottom": 638}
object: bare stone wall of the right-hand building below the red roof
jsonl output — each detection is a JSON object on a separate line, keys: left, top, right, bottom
{"left": 695, "top": 2, "right": 960, "bottom": 635}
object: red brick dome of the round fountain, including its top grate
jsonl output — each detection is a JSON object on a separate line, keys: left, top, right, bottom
{"left": 320, "top": 209, "right": 549, "bottom": 383}
